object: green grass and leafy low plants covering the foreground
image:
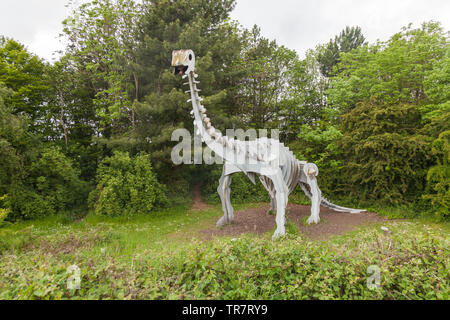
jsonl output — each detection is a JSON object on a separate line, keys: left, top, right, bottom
{"left": 0, "top": 205, "right": 449, "bottom": 299}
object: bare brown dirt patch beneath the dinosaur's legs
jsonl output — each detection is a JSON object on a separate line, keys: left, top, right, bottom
{"left": 200, "top": 204, "right": 387, "bottom": 240}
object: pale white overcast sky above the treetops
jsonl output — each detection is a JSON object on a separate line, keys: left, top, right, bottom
{"left": 0, "top": 0, "right": 450, "bottom": 61}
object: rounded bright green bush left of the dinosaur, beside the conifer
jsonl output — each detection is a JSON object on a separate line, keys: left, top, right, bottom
{"left": 89, "top": 151, "right": 167, "bottom": 216}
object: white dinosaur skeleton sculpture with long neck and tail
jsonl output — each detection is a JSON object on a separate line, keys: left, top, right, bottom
{"left": 172, "top": 50, "right": 364, "bottom": 238}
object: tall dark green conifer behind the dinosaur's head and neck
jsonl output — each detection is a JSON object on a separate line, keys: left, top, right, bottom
{"left": 132, "top": 0, "right": 241, "bottom": 187}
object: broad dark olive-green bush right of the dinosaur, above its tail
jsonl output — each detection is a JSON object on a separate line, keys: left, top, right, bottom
{"left": 339, "top": 102, "right": 432, "bottom": 205}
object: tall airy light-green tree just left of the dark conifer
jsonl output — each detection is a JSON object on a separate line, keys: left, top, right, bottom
{"left": 63, "top": 0, "right": 139, "bottom": 137}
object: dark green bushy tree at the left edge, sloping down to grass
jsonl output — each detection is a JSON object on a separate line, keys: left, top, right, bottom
{"left": 0, "top": 83, "right": 88, "bottom": 220}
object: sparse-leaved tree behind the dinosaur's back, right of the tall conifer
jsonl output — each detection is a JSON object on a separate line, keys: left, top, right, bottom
{"left": 231, "top": 25, "right": 298, "bottom": 129}
